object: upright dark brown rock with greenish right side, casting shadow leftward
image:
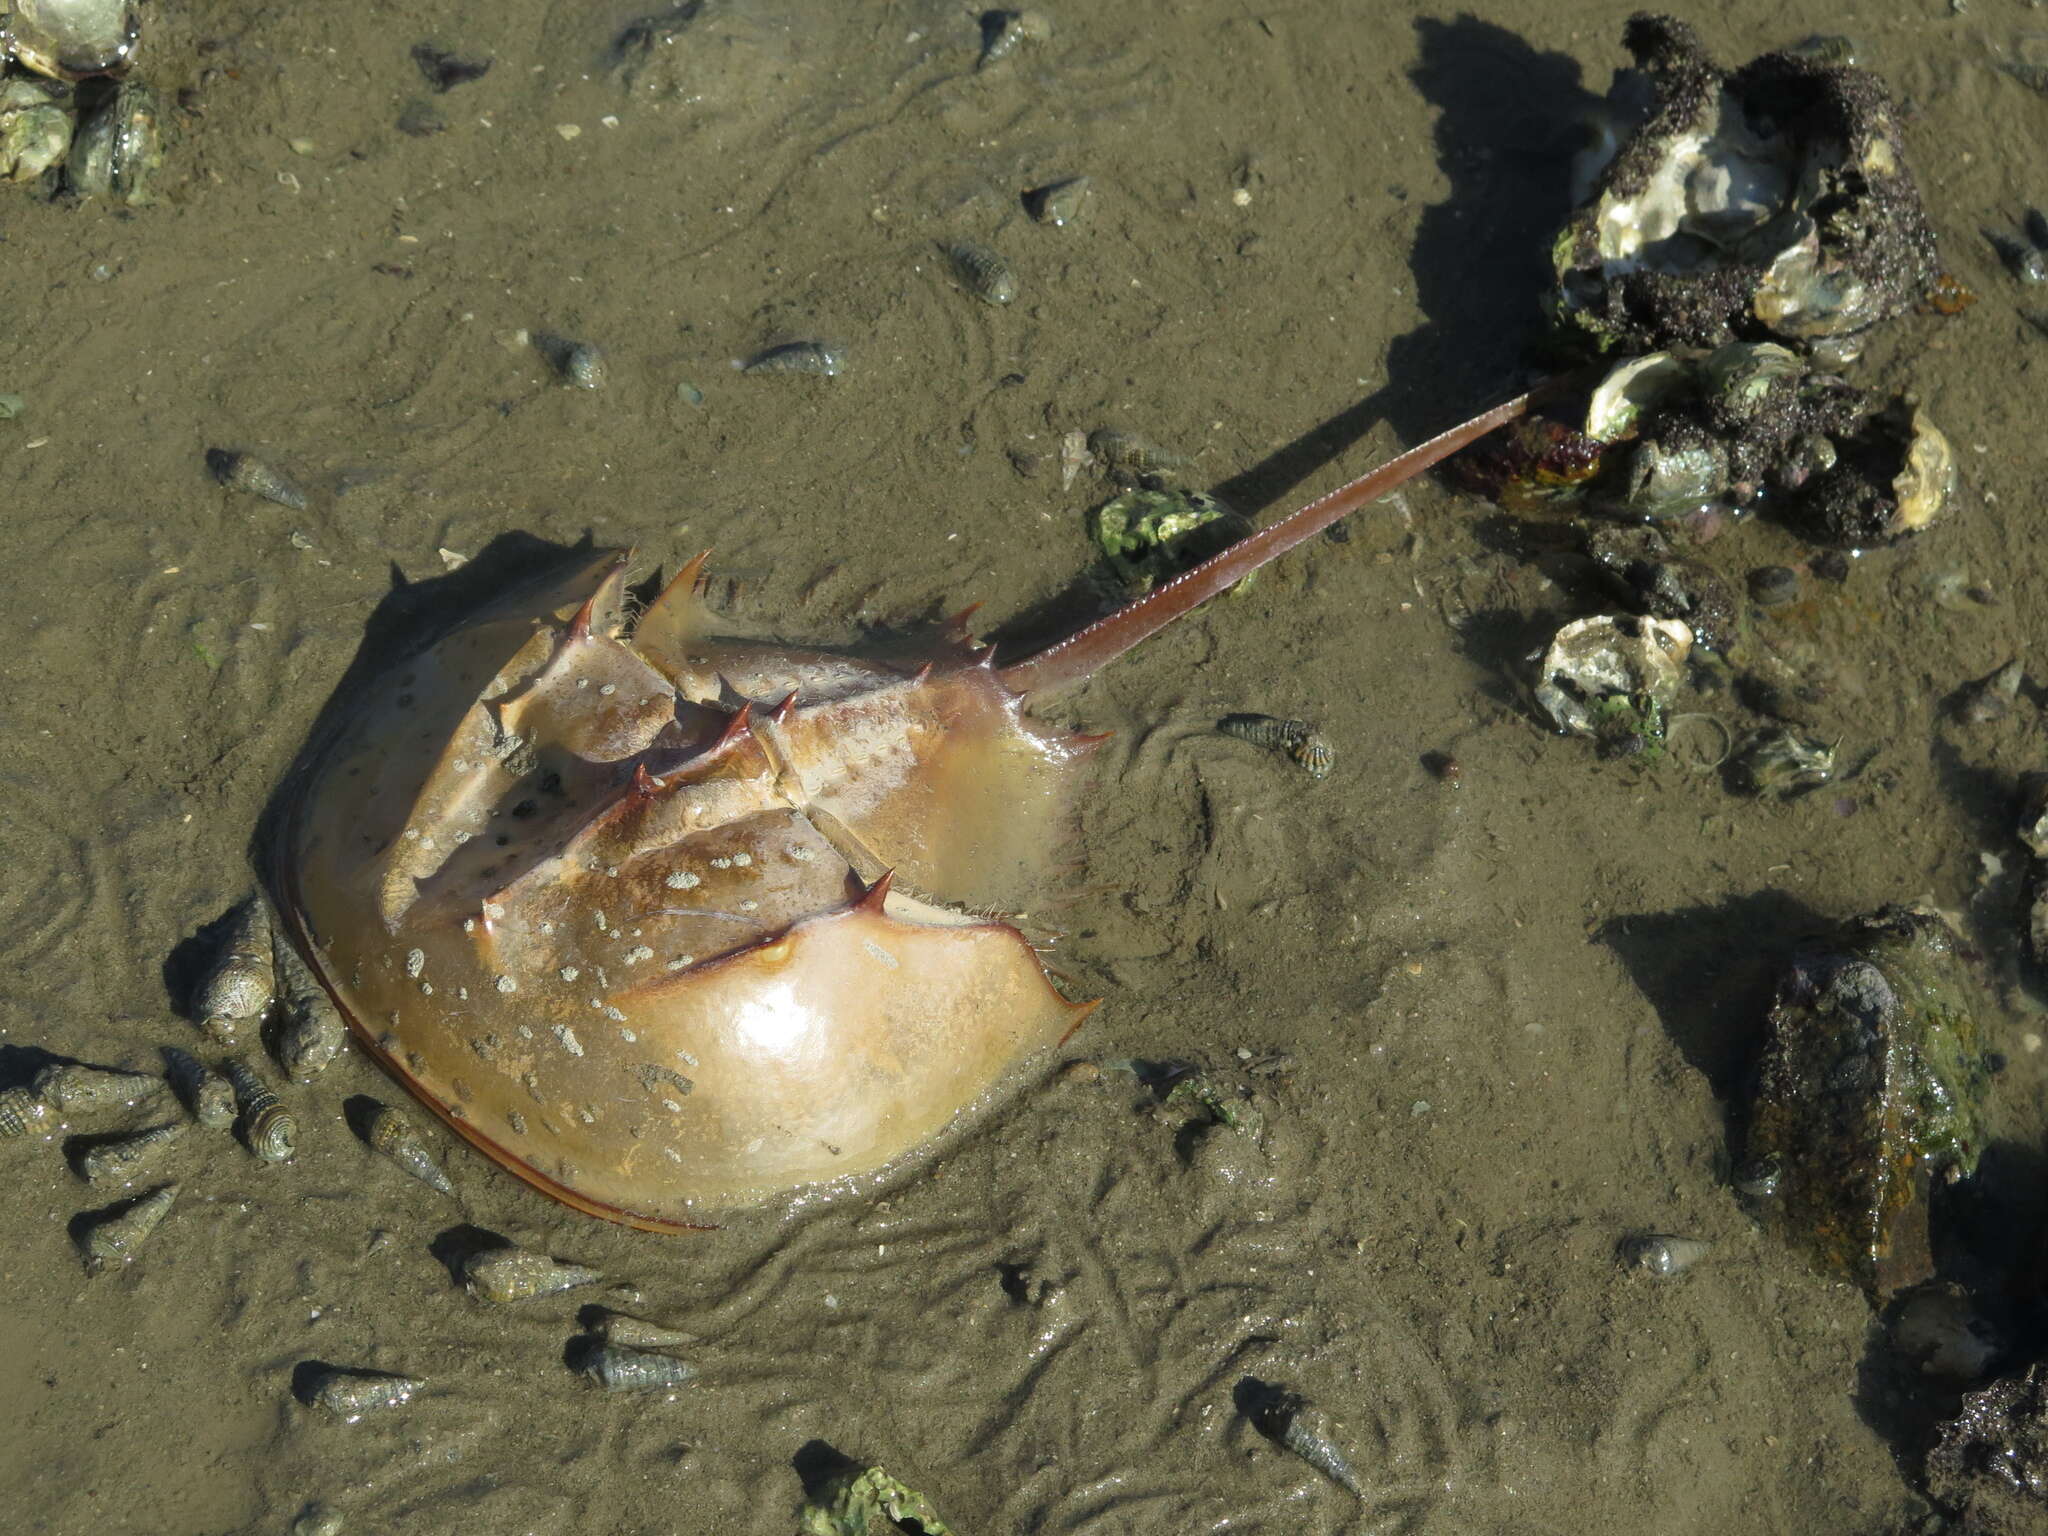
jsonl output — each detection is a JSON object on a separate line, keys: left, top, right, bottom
{"left": 1747, "top": 905, "right": 1985, "bottom": 1298}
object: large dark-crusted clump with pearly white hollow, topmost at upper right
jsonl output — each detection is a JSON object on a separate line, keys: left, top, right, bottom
{"left": 1550, "top": 14, "right": 1935, "bottom": 352}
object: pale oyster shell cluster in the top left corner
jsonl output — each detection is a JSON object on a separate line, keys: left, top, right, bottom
{"left": 0, "top": 0, "right": 164, "bottom": 205}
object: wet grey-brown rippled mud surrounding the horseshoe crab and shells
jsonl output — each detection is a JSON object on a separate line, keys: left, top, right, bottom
{"left": 0, "top": 0, "right": 2048, "bottom": 1536}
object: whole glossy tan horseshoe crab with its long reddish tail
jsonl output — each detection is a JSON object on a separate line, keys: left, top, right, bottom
{"left": 268, "top": 397, "right": 1526, "bottom": 1231}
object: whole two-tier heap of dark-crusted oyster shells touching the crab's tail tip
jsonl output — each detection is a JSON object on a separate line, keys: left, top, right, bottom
{"left": 1466, "top": 16, "right": 1956, "bottom": 549}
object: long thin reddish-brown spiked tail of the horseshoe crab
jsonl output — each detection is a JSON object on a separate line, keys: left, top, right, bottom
{"left": 997, "top": 389, "right": 1542, "bottom": 694}
